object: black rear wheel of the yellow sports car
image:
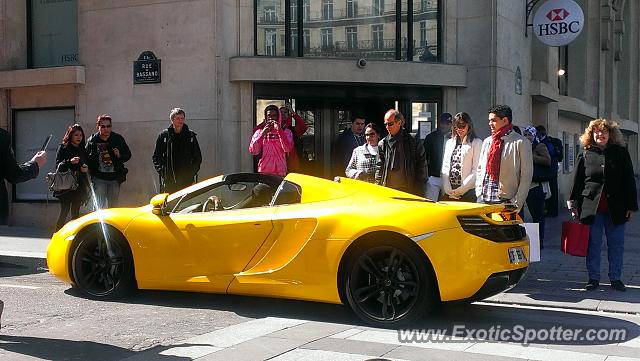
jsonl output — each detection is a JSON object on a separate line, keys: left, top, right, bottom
{"left": 343, "top": 241, "right": 436, "bottom": 328}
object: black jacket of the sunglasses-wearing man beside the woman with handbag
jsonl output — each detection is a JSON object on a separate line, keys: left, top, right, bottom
{"left": 87, "top": 132, "right": 131, "bottom": 183}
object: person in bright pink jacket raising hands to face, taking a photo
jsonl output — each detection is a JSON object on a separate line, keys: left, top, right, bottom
{"left": 249, "top": 105, "right": 293, "bottom": 177}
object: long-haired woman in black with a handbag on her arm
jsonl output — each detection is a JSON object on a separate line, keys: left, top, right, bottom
{"left": 53, "top": 124, "right": 89, "bottom": 231}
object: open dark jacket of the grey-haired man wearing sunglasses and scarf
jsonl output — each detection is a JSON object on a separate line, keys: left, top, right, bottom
{"left": 375, "top": 129, "right": 427, "bottom": 197}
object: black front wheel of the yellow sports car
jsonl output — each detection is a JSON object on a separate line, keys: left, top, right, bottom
{"left": 71, "top": 231, "right": 136, "bottom": 299}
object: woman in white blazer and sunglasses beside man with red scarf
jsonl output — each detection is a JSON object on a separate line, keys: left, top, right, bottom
{"left": 440, "top": 112, "right": 482, "bottom": 202}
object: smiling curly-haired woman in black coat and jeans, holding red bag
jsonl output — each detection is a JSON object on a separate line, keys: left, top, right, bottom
{"left": 569, "top": 119, "right": 638, "bottom": 291}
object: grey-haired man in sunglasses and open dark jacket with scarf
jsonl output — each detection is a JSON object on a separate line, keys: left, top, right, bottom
{"left": 375, "top": 109, "right": 427, "bottom": 196}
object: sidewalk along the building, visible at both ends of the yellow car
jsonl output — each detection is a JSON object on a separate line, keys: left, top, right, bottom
{"left": 0, "top": 210, "right": 640, "bottom": 314}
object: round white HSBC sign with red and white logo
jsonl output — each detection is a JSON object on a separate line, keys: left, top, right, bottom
{"left": 533, "top": 0, "right": 584, "bottom": 46}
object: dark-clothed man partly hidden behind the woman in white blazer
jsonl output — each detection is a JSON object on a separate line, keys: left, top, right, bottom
{"left": 424, "top": 113, "right": 451, "bottom": 201}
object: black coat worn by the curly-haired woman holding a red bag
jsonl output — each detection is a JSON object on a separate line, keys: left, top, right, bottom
{"left": 569, "top": 144, "right": 638, "bottom": 224}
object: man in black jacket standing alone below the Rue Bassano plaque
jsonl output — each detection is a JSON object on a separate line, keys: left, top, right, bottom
{"left": 153, "top": 108, "right": 202, "bottom": 193}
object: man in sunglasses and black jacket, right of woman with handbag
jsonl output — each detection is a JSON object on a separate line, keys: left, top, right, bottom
{"left": 87, "top": 114, "right": 131, "bottom": 209}
